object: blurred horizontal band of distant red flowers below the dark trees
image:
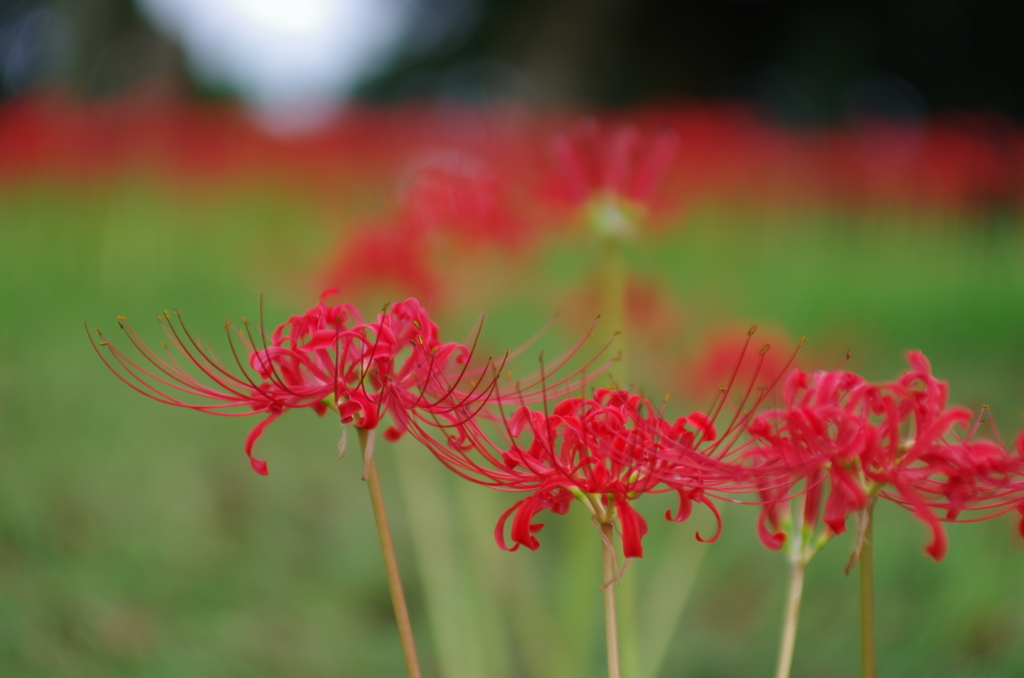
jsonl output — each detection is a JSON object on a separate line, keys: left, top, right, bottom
{"left": 8, "top": 91, "right": 1024, "bottom": 216}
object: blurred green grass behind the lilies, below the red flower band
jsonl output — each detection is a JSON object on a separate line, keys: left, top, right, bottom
{"left": 0, "top": 179, "right": 1024, "bottom": 678}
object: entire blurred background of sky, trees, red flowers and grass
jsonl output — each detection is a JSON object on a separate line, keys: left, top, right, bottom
{"left": 0, "top": 0, "right": 1024, "bottom": 678}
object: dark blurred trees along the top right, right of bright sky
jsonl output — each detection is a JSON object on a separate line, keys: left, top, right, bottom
{"left": 364, "top": 0, "right": 1024, "bottom": 124}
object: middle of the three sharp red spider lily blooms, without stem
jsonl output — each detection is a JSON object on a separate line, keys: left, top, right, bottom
{"left": 413, "top": 389, "right": 753, "bottom": 557}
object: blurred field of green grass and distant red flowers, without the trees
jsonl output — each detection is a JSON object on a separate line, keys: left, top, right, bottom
{"left": 0, "top": 100, "right": 1024, "bottom": 678}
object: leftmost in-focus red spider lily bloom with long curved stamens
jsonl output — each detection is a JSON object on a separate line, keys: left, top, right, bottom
{"left": 94, "top": 290, "right": 475, "bottom": 475}
